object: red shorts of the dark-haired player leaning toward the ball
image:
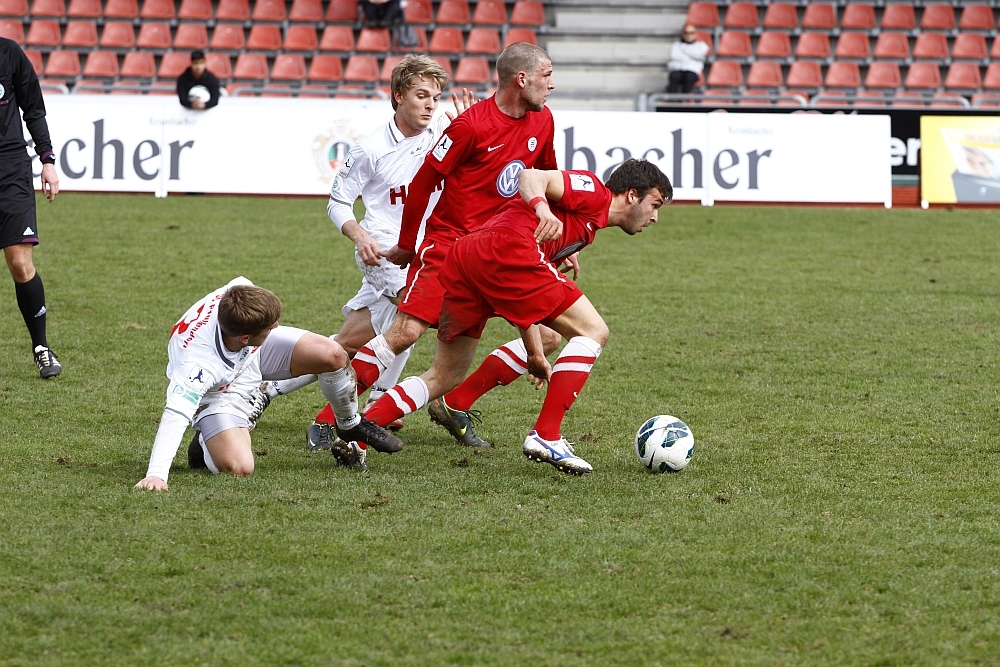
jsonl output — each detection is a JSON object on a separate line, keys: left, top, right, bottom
{"left": 438, "top": 228, "right": 583, "bottom": 343}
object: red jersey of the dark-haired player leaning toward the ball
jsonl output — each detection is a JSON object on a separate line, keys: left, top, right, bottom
{"left": 483, "top": 171, "right": 612, "bottom": 264}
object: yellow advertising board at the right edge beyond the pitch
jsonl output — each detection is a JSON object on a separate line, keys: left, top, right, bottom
{"left": 920, "top": 116, "right": 1000, "bottom": 205}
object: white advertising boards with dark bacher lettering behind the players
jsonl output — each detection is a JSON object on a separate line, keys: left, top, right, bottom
{"left": 25, "top": 96, "right": 892, "bottom": 207}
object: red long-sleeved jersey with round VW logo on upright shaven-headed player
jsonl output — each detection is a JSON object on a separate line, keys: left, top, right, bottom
{"left": 399, "top": 97, "right": 558, "bottom": 250}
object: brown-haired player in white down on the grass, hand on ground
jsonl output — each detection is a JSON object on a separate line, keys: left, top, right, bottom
{"left": 136, "top": 277, "right": 399, "bottom": 491}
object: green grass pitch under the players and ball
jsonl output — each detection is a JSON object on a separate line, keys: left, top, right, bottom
{"left": 0, "top": 194, "right": 1000, "bottom": 666}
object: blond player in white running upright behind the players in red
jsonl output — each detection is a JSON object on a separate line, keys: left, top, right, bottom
{"left": 244, "top": 55, "right": 475, "bottom": 463}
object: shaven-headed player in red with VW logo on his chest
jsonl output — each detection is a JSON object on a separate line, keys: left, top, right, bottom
{"left": 309, "top": 42, "right": 572, "bottom": 454}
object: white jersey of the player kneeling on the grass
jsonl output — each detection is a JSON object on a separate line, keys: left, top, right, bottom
{"left": 166, "top": 276, "right": 261, "bottom": 422}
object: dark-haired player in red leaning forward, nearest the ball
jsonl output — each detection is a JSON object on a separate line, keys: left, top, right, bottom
{"left": 365, "top": 159, "right": 673, "bottom": 475}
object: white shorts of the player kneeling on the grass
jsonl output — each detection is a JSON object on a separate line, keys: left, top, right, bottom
{"left": 194, "top": 326, "right": 307, "bottom": 428}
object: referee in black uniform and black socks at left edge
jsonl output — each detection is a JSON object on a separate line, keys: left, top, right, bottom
{"left": 0, "top": 37, "right": 62, "bottom": 378}
